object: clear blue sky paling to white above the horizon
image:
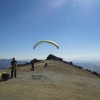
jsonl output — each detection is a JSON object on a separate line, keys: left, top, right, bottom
{"left": 0, "top": 0, "right": 100, "bottom": 60}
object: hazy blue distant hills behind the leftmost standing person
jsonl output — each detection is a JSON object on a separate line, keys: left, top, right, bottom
{"left": 0, "top": 59, "right": 28, "bottom": 69}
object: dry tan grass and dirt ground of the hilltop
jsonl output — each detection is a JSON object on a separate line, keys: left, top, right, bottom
{"left": 0, "top": 61, "right": 100, "bottom": 100}
